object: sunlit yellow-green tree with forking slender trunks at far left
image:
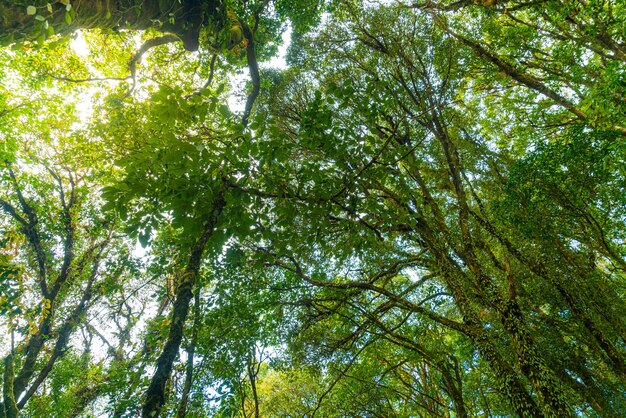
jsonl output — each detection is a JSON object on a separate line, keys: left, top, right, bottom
{"left": 0, "top": 81, "right": 134, "bottom": 416}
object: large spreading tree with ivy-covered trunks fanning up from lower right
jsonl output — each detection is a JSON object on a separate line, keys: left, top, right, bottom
{"left": 240, "top": 1, "right": 623, "bottom": 416}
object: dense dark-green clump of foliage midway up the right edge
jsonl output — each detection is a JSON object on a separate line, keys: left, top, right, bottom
{"left": 502, "top": 127, "right": 626, "bottom": 245}
